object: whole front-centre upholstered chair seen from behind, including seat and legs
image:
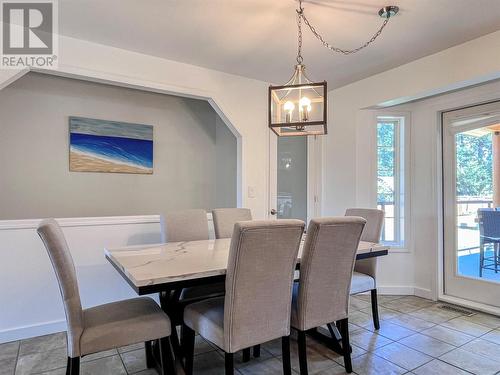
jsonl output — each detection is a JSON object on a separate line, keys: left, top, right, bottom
{"left": 183, "top": 220, "right": 305, "bottom": 375}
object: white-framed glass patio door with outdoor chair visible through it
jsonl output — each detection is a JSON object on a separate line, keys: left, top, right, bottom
{"left": 442, "top": 102, "right": 500, "bottom": 308}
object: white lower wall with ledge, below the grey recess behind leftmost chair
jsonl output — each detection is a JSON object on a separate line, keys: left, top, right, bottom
{"left": 0, "top": 214, "right": 213, "bottom": 343}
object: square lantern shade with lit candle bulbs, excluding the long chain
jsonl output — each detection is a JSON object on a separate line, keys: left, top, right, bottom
{"left": 269, "top": 64, "right": 327, "bottom": 136}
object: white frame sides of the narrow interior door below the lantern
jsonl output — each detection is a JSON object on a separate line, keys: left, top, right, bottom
{"left": 267, "top": 131, "right": 324, "bottom": 224}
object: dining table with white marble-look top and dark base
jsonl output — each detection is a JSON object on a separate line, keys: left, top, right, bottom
{"left": 104, "top": 238, "right": 389, "bottom": 363}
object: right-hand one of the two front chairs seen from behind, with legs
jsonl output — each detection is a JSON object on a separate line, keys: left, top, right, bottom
{"left": 291, "top": 217, "right": 366, "bottom": 375}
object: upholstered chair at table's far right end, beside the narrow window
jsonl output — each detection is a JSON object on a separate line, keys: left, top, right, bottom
{"left": 345, "top": 208, "right": 384, "bottom": 329}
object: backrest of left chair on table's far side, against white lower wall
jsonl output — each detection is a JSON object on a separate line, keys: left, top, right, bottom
{"left": 160, "top": 209, "right": 208, "bottom": 242}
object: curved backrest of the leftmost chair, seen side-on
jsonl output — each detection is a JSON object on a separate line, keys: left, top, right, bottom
{"left": 35, "top": 219, "right": 84, "bottom": 358}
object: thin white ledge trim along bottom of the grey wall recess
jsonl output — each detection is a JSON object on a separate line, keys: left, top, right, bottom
{"left": 0, "top": 212, "right": 212, "bottom": 231}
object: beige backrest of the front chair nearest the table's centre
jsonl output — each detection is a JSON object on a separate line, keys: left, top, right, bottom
{"left": 224, "top": 220, "right": 305, "bottom": 353}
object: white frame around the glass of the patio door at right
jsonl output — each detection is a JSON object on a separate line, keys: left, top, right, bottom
{"left": 439, "top": 101, "right": 500, "bottom": 314}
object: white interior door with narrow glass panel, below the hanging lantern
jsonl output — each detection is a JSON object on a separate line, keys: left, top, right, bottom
{"left": 269, "top": 134, "right": 321, "bottom": 223}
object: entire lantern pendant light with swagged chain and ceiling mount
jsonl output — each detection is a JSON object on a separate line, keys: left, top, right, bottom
{"left": 269, "top": 0, "right": 399, "bottom": 136}
